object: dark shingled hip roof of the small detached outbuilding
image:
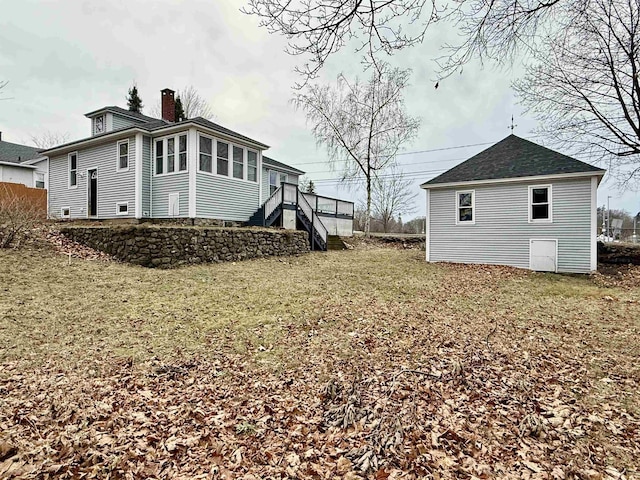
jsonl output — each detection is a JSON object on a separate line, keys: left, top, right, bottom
{"left": 422, "top": 135, "right": 604, "bottom": 186}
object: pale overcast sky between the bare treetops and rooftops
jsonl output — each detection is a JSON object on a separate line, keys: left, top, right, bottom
{"left": 0, "top": 0, "right": 640, "bottom": 219}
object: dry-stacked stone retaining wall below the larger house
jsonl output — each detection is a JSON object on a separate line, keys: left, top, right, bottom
{"left": 60, "top": 224, "right": 309, "bottom": 268}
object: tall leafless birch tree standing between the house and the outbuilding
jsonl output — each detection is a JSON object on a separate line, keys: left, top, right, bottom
{"left": 293, "top": 64, "right": 420, "bottom": 235}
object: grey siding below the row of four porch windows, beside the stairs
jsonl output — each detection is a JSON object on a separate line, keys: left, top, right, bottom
{"left": 196, "top": 173, "right": 262, "bottom": 222}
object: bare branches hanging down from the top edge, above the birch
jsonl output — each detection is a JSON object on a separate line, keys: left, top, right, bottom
{"left": 243, "top": 0, "right": 568, "bottom": 80}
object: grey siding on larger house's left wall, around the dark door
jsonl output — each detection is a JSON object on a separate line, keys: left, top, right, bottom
{"left": 49, "top": 137, "right": 136, "bottom": 218}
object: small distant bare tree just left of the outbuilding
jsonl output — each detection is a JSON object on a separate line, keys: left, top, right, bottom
{"left": 371, "top": 167, "right": 417, "bottom": 233}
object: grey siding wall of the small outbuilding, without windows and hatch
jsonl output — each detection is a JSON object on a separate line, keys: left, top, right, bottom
{"left": 427, "top": 178, "right": 595, "bottom": 273}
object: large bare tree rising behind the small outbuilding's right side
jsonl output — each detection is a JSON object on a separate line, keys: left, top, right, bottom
{"left": 514, "top": 0, "right": 640, "bottom": 185}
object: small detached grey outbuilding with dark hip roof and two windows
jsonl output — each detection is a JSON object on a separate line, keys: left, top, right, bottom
{"left": 422, "top": 135, "right": 605, "bottom": 273}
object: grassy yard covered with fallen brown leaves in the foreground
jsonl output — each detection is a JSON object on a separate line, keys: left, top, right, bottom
{"left": 0, "top": 245, "right": 640, "bottom": 479}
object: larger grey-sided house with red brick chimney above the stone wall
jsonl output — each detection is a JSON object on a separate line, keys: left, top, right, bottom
{"left": 44, "top": 89, "right": 356, "bottom": 249}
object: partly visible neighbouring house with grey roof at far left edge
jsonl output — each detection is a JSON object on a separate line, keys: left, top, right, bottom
{"left": 0, "top": 132, "right": 48, "bottom": 188}
